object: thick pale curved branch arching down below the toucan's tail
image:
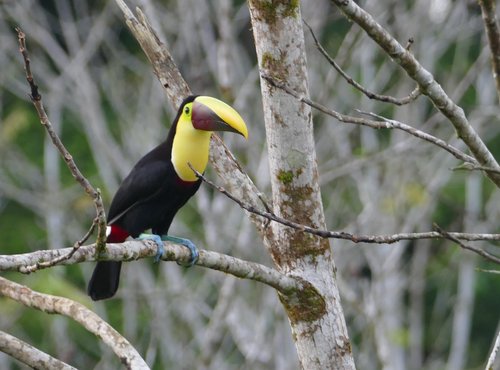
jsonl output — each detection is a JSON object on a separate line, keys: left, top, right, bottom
{"left": 0, "top": 277, "right": 149, "bottom": 369}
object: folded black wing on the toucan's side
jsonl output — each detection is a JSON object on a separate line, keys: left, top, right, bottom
{"left": 108, "top": 161, "right": 173, "bottom": 224}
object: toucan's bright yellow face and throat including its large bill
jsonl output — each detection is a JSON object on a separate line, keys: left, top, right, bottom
{"left": 171, "top": 96, "right": 248, "bottom": 181}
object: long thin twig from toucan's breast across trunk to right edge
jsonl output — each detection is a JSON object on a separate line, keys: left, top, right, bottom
{"left": 188, "top": 163, "right": 500, "bottom": 264}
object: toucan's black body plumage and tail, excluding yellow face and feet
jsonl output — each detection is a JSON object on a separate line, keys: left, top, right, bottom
{"left": 87, "top": 96, "right": 201, "bottom": 300}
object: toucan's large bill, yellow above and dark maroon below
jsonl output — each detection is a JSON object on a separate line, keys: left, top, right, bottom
{"left": 191, "top": 96, "right": 248, "bottom": 139}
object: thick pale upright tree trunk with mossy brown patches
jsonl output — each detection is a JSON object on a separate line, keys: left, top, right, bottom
{"left": 249, "top": 0, "right": 354, "bottom": 369}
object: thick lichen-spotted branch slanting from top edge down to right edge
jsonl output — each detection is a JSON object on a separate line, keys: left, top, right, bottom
{"left": 331, "top": 0, "right": 500, "bottom": 187}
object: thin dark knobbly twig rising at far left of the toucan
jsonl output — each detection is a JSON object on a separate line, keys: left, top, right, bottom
{"left": 16, "top": 27, "right": 106, "bottom": 258}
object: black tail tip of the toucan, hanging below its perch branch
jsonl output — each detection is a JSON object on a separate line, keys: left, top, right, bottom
{"left": 87, "top": 261, "right": 122, "bottom": 301}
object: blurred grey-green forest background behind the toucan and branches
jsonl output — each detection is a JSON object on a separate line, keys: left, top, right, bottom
{"left": 0, "top": 0, "right": 500, "bottom": 370}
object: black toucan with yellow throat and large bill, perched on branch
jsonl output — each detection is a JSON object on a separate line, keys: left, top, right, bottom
{"left": 87, "top": 95, "right": 248, "bottom": 301}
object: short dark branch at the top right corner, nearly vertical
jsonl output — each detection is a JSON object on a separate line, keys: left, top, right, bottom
{"left": 478, "top": 0, "right": 500, "bottom": 99}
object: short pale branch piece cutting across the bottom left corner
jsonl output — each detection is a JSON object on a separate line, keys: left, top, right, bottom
{"left": 0, "top": 330, "right": 76, "bottom": 370}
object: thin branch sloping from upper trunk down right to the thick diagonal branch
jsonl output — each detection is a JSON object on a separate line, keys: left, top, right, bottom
{"left": 263, "top": 75, "right": 479, "bottom": 166}
